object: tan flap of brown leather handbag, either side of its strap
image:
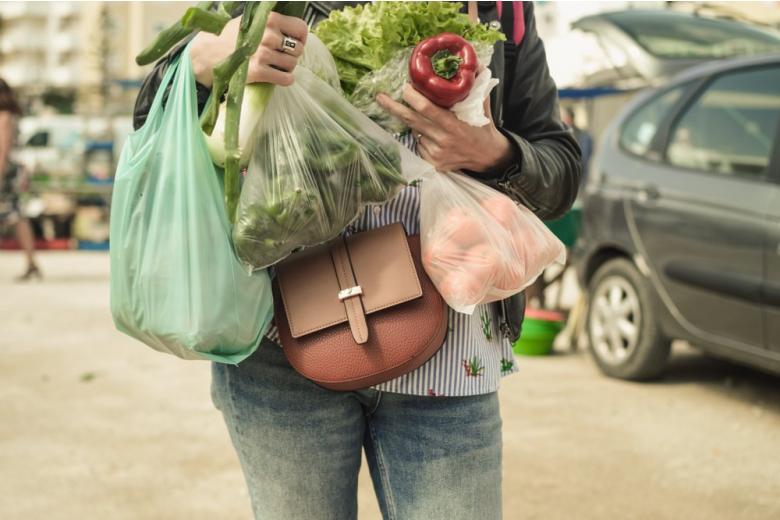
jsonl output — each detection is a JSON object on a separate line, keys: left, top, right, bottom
{"left": 277, "top": 224, "right": 422, "bottom": 338}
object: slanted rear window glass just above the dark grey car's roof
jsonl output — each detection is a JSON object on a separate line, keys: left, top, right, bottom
{"left": 607, "top": 11, "right": 780, "bottom": 59}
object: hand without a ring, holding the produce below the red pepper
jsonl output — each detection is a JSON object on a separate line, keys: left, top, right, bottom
{"left": 377, "top": 85, "right": 513, "bottom": 173}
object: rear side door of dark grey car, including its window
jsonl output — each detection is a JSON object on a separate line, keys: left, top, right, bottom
{"left": 626, "top": 66, "right": 780, "bottom": 349}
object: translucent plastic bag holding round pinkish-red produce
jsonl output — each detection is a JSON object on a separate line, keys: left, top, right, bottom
{"left": 420, "top": 173, "right": 566, "bottom": 314}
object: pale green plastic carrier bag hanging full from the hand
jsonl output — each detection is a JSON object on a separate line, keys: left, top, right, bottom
{"left": 111, "top": 44, "right": 273, "bottom": 364}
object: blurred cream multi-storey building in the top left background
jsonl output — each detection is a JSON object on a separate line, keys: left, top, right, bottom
{"left": 0, "top": 1, "right": 183, "bottom": 114}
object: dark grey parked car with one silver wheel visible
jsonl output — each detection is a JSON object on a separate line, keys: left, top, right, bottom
{"left": 574, "top": 55, "right": 780, "bottom": 380}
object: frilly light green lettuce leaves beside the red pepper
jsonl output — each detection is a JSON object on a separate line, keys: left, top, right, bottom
{"left": 314, "top": 2, "right": 505, "bottom": 94}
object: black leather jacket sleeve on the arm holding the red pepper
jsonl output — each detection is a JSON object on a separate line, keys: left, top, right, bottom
{"left": 485, "top": 2, "right": 582, "bottom": 220}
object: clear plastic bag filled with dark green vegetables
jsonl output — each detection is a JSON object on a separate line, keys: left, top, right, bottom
{"left": 233, "top": 67, "right": 426, "bottom": 269}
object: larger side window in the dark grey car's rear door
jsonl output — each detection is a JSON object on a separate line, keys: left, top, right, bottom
{"left": 666, "top": 67, "right": 780, "bottom": 176}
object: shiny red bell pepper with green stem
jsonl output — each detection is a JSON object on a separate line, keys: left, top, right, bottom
{"left": 409, "top": 33, "right": 479, "bottom": 108}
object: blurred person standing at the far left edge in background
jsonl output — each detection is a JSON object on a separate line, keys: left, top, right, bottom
{"left": 0, "top": 79, "right": 41, "bottom": 282}
